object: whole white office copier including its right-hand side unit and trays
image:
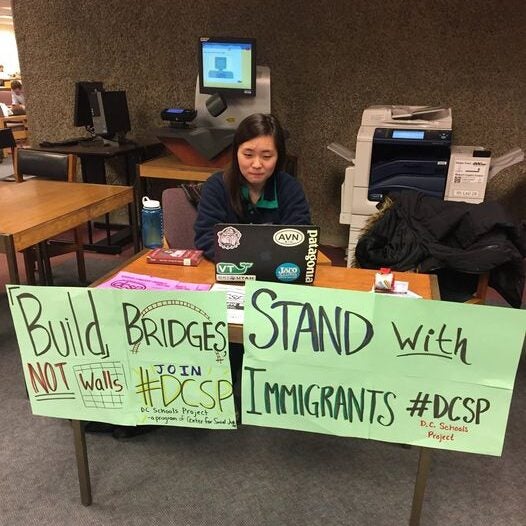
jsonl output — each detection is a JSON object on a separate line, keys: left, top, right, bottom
{"left": 334, "top": 106, "right": 524, "bottom": 266}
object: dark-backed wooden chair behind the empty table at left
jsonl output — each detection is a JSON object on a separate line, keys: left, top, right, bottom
{"left": 14, "top": 149, "right": 86, "bottom": 285}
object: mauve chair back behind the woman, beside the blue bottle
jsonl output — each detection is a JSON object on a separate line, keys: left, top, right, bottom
{"left": 162, "top": 188, "right": 197, "bottom": 248}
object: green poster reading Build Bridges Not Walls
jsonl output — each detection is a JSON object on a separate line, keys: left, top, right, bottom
{"left": 8, "top": 286, "right": 236, "bottom": 429}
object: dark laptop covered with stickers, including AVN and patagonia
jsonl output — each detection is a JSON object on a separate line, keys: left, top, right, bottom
{"left": 214, "top": 223, "right": 320, "bottom": 285}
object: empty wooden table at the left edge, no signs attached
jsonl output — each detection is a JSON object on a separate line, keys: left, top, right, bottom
{"left": 0, "top": 179, "right": 139, "bottom": 283}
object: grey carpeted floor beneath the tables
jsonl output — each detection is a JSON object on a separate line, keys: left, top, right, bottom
{"left": 0, "top": 221, "right": 526, "bottom": 526}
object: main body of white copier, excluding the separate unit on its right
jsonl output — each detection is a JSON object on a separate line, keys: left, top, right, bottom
{"left": 340, "top": 106, "right": 452, "bottom": 266}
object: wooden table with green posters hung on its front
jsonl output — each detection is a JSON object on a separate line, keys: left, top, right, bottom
{"left": 76, "top": 255, "right": 440, "bottom": 526}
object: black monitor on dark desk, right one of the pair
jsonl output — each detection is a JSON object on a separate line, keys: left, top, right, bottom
{"left": 89, "top": 91, "right": 131, "bottom": 139}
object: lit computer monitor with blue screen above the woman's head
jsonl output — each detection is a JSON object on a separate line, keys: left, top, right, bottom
{"left": 199, "top": 37, "right": 256, "bottom": 97}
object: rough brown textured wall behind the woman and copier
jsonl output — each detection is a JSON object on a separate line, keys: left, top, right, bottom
{"left": 14, "top": 0, "right": 526, "bottom": 245}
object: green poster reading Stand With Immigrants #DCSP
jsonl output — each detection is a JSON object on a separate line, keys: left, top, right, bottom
{"left": 242, "top": 282, "right": 526, "bottom": 455}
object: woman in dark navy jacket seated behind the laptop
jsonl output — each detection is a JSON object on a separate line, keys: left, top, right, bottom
{"left": 194, "top": 113, "right": 311, "bottom": 260}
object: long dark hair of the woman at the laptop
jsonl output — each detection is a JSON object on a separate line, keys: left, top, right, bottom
{"left": 224, "top": 113, "right": 286, "bottom": 216}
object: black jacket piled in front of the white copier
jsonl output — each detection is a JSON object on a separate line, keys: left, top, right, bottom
{"left": 356, "top": 190, "right": 526, "bottom": 308}
